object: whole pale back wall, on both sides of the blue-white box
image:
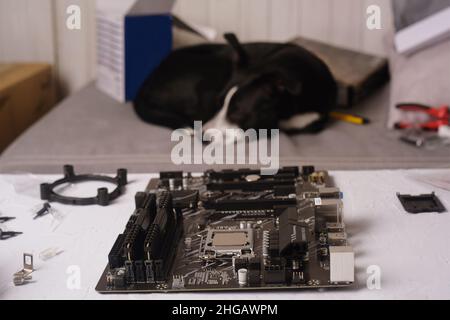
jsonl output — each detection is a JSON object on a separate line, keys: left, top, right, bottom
{"left": 0, "top": 0, "right": 391, "bottom": 94}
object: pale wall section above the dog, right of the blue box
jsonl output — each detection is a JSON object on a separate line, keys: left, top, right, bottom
{"left": 174, "top": 0, "right": 392, "bottom": 55}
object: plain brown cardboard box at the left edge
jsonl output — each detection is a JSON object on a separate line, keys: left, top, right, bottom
{"left": 0, "top": 64, "right": 55, "bottom": 152}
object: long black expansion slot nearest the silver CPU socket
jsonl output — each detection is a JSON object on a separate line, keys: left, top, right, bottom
{"left": 204, "top": 198, "right": 297, "bottom": 211}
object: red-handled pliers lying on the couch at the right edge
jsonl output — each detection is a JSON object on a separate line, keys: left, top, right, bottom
{"left": 395, "top": 103, "right": 450, "bottom": 131}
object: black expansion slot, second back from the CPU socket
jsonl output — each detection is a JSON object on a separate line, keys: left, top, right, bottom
{"left": 206, "top": 179, "right": 295, "bottom": 191}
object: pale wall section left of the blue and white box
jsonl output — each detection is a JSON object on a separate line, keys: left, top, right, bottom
{"left": 0, "top": 0, "right": 96, "bottom": 96}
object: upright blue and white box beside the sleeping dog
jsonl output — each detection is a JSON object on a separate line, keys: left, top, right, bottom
{"left": 97, "top": 0, "right": 174, "bottom": 102}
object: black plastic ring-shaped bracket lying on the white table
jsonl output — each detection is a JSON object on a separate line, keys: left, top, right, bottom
{"left": 41, "top": 165, "right": 128, "bottom": 206}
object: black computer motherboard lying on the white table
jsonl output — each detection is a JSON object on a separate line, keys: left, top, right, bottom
{"left": 96, "top": 166, "right": 354, "bottom": 293}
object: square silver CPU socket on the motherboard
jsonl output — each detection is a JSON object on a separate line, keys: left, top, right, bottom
{"left": 200, "top": 228, "right": 253, "bottom": 260}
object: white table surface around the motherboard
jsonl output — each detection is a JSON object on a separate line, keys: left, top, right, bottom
{"left": 0, "top": 170, "right": 450, "bottom": 300}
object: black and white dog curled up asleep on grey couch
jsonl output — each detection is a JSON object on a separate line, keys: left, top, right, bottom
{"left": 134, "top": 34, "right": 337, "bottom": 133}
